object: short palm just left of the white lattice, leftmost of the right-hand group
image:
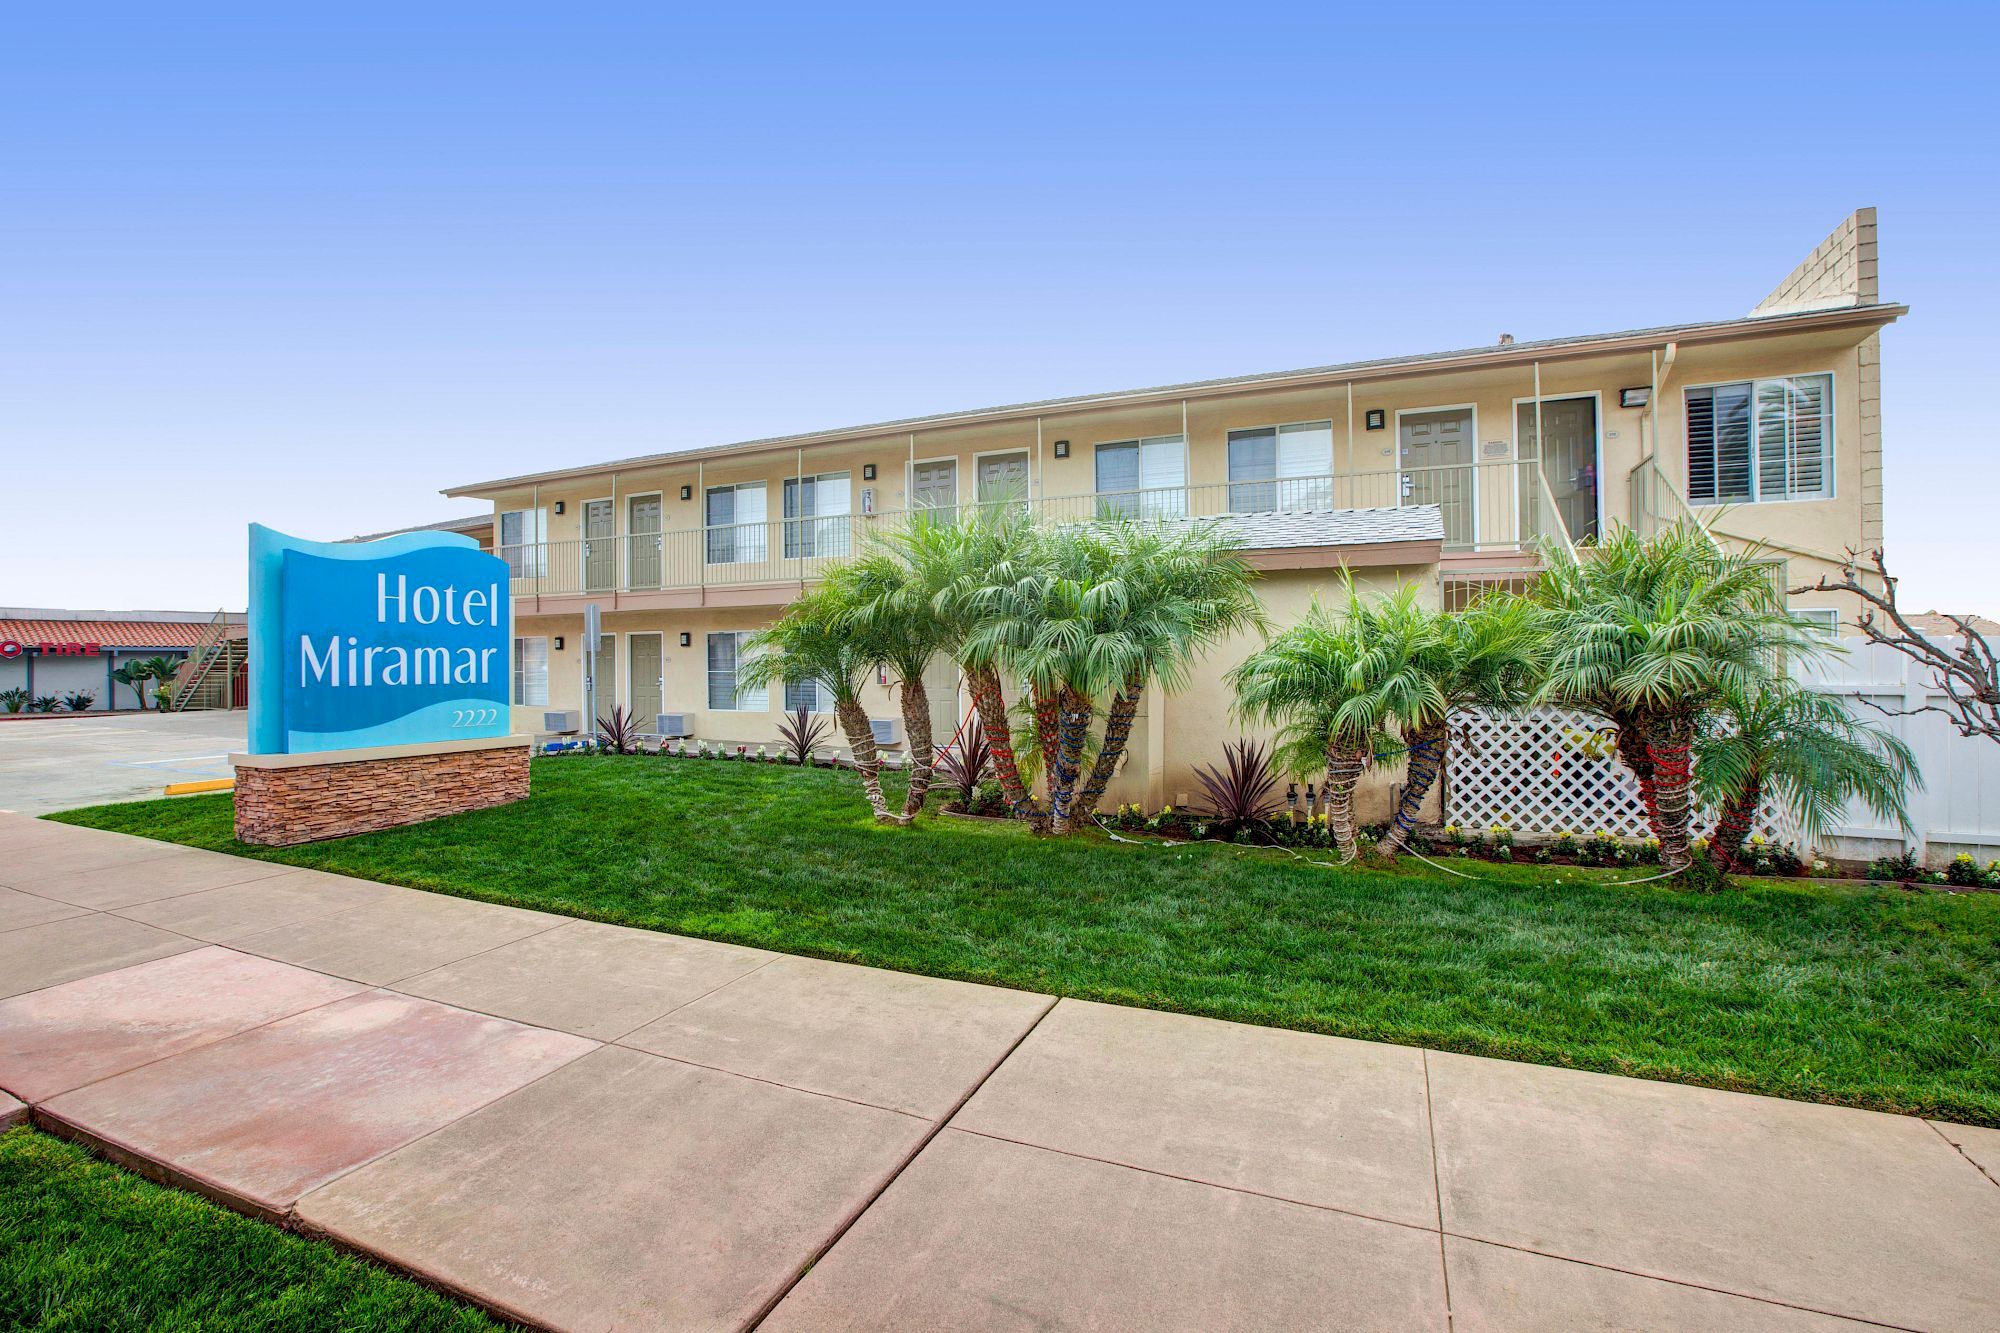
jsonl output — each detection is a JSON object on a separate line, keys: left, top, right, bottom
{"left": 1226, "top": 578, "right": 1388, "bottom": 863}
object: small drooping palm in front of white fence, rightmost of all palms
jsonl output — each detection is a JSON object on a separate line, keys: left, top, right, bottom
{"left": 1694, "top": 679, "right": 1924, "bottom": 875}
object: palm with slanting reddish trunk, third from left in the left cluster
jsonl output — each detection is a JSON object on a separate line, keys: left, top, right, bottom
{"left": 878, "top": 504, "right": 1040, "bottom": 819}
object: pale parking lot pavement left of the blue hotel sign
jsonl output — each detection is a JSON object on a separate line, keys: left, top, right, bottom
{"left": 0, "top": 711, "right": 250, "bottom": 815}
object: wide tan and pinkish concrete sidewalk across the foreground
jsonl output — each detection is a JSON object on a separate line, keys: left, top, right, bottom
{"left": 0, "top": 817, "right": 2000, "bottom": 1331}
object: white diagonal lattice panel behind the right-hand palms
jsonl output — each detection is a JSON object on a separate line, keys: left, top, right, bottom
{"left": 1444, "top": 709, "right": 1798, "bottom": 843}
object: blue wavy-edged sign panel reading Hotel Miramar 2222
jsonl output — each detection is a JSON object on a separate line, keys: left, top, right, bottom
{"left": 250, "top": 524, "right": 514, "bottom": 755}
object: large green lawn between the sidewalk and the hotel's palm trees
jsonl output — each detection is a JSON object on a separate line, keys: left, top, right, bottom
{"left": 62, "top": 759, "right": 2000, "bottom": 1125}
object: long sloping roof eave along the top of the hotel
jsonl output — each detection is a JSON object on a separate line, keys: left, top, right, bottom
{"left": 442, "top": 302, "right": 1910, "bottom": 498}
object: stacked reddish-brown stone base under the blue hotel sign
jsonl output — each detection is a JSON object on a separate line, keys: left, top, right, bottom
{"left": 230, "top": 737, "right": 530, "bottom": 847}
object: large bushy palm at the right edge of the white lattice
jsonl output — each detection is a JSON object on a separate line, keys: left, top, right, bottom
{"left": 1530, "top": 522, "right": 1826, "bottom": 869}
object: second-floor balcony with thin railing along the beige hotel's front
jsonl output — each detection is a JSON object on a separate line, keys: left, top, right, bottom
{"left": 496, "top": 458, "right": 1570, "bottom": 600}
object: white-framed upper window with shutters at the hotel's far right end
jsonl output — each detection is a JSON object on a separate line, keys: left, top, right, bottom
{"left": 1686, "top": 374, "right": 1834, "bottom": 504}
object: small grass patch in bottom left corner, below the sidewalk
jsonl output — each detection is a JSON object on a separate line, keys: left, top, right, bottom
{"left": 0, "top": 1129, "right": 500, "bottom": 1333}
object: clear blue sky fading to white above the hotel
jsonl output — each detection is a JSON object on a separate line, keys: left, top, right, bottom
{"left": 0, "top": 2, "right": 2000, "bottom": 612}
